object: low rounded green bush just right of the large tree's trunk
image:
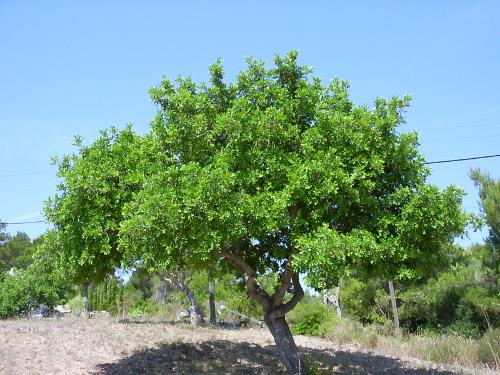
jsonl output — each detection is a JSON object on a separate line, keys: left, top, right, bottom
{"left": 288, "top": 303, "right": 338, "bottom": 336}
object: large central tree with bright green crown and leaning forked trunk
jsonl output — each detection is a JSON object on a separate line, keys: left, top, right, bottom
{"left": 119, "top": 52, "right": 467, "bottom": 374}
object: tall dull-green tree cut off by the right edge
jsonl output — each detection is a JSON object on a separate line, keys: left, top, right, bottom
{"left": 470, "top": 169, "right": 500, "bottom": 289}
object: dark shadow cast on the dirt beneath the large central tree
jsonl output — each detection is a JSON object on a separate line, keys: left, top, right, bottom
{"left": 94, "top": 340, "right": 454, "bottom": 375}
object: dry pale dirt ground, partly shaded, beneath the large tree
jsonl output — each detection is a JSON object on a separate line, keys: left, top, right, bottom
{"left": 0, "top": 318, "right": 493, "bottom": 375}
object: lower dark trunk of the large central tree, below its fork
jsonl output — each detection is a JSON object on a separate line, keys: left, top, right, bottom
{"left": 264, "top": 313, "right": 306, "bottom": 375}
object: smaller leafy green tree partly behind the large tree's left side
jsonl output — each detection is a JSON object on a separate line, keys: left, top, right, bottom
{"left": 45, "top": 126, "right": 158, "bottom": 315}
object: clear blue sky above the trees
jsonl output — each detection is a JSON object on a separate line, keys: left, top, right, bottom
{"left": 0, "top": 0, "right": 500, "bottom": 247}
